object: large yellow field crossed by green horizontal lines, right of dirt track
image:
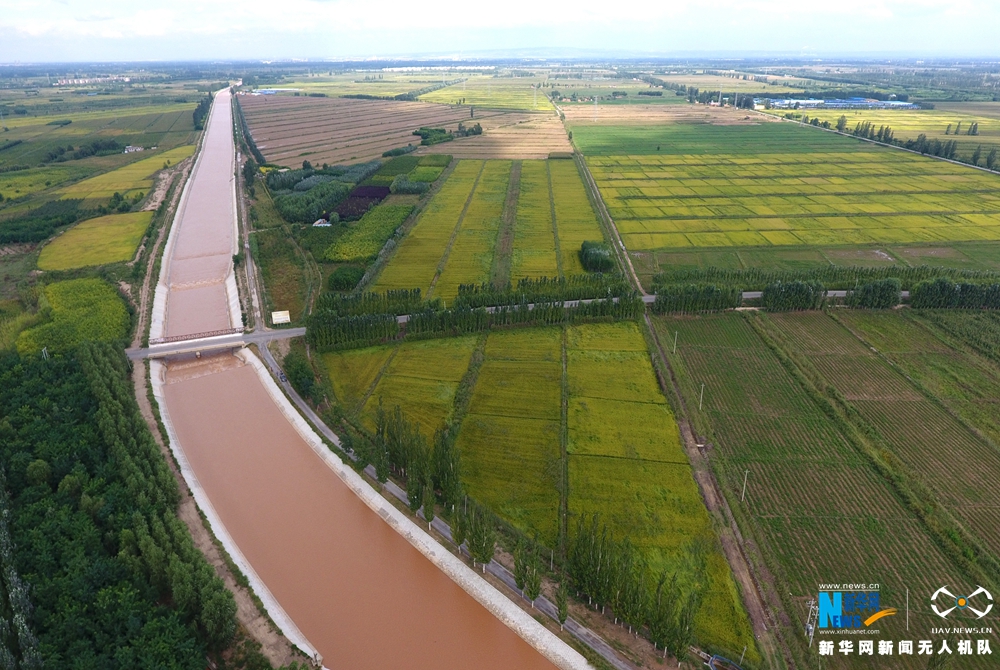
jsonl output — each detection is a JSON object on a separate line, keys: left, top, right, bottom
{"left": 588, "top": 148, "right": 1000, "bottom": 250}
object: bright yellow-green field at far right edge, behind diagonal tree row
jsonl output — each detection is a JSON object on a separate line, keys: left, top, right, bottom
{"left": 807, "top": 103, "right": 1000, "bottom": 166}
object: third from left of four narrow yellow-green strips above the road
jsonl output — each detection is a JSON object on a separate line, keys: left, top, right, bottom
{"left": 510, "top": 161, "right": 559, "bottom": 283}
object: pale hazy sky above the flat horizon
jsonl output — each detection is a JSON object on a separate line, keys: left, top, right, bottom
{"left": 0, "top": 0, "right": 1000, "bottom": 63}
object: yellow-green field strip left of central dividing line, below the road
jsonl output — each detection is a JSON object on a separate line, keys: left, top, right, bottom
{"left": 456, "top": 327, "right": 563, "bottom": 547}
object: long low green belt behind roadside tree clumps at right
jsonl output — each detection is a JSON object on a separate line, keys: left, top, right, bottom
{"left": 652, "top": 265, "right": 1000, "bottom": 293}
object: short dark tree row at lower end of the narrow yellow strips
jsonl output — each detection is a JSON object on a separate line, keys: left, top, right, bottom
{"left": 454, "top": 273, "right": 632, "bottom": 307}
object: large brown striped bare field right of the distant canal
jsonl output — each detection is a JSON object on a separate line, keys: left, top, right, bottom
{"left": 239, "top": 95, "right": 528, "bottom": 167}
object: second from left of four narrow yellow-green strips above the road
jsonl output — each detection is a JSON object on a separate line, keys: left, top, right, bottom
{"left": 433, "top": 161, "right": 511, "bottom": 300}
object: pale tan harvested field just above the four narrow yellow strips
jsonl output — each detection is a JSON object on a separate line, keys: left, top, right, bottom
{"left": 417, "top": 112, "right": 573, "bottom": 159}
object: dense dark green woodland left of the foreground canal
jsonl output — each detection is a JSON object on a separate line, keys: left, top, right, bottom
{"left": 0, "top": 344, "right": 236, "bottom": 670}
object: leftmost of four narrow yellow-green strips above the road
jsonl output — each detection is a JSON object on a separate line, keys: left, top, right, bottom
{"left": 374, "top": 161, "right": 484, "bottom": 295}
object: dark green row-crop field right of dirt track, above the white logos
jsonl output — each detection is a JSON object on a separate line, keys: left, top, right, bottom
{"left": 655, "top": 313, "right": 987, "bottom": 667}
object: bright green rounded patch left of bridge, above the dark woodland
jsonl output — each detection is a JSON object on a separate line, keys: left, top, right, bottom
{"left": 17, "top": 279, "right": 129, "bottom": 355}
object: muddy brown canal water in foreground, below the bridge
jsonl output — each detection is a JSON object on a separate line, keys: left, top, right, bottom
{"left": 164, "top": 354, "right": 555, "bottom": 670}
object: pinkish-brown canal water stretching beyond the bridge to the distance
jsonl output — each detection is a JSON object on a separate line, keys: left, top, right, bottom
{"left": 164, "top": 90, "right": 237, "bottom": 336}
